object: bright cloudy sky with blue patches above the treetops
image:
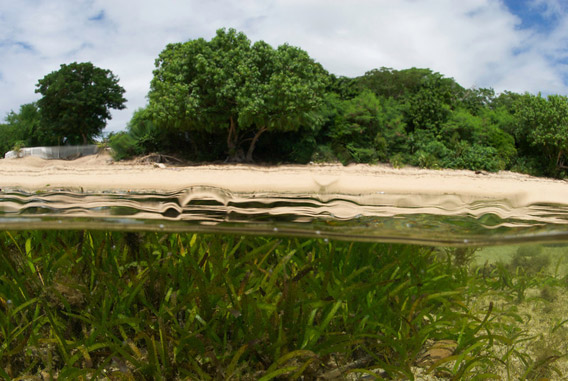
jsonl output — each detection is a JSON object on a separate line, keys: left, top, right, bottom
{"left": 0, "top": 0, "right": 568, "bottom": 133}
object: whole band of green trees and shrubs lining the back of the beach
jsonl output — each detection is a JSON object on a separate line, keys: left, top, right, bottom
{"left": 4, "top": 29, "right": 568, "bottom": 177}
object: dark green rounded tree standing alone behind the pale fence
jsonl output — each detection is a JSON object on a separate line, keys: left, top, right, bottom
{"left": 36, "top": 62, "right": 126, "bottom": 144}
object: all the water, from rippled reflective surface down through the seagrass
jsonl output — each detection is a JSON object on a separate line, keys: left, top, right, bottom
{"left": 0, "top": 187, "right": 568, "bottom": 380}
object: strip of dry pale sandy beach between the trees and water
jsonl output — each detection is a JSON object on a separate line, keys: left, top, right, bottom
{"left": 0, "top": 153, "right": 568, "bottom": 206}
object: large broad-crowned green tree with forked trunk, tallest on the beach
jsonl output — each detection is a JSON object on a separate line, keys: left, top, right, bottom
{"left": 148, "top": 29, "right": 328, "bottom": 161}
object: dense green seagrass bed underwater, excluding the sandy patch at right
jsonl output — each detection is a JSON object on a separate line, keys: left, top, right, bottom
{"left": 0, "top": 232, "right": 470, "bottom": 379}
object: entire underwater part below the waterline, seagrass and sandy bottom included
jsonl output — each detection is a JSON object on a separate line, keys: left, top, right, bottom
{"left": 0, "top": 230, "right": 568, "bottom": 380}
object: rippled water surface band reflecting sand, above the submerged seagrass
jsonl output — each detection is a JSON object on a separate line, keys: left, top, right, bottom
{"left": 0, "top": 187, "right": 568, "bottom": 246}
